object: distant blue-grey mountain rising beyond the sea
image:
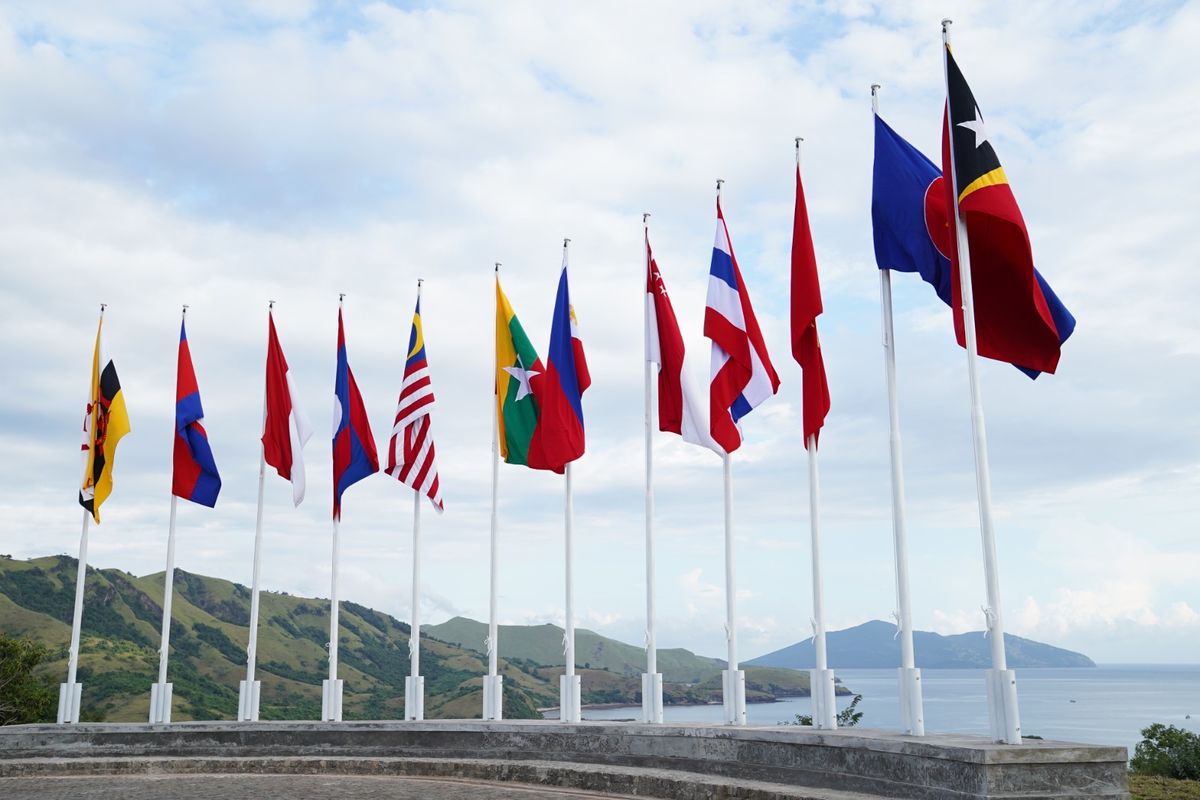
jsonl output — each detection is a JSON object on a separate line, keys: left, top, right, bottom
{"left": 746, "top": 620, "right": 1096, "bottom": 669}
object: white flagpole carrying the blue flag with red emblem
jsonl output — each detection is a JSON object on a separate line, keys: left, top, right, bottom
{"left": 871, "top": 84, "right": 925, "bottom": 736}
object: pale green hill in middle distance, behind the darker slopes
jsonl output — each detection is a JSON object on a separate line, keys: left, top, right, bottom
{"left": 421, "top": 616, "right": 725, "bottom": 684}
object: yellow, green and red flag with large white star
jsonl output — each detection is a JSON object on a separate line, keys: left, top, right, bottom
{"left": 496, "top": 276, "right": 546, "bottom": 465}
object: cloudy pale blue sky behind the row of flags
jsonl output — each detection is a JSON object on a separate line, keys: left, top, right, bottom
{"left": 0, "top": 0, "right": 1200, "bottom": 663}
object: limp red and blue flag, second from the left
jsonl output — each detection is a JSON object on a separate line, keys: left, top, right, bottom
{"left": 172, "top": 323, "right": 221, "bottom": 509}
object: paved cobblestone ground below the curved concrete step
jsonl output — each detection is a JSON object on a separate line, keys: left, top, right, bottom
{"left": 0, "top": 775, "right": 613, "bottom": 800}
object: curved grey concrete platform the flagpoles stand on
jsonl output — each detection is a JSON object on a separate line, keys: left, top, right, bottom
{"left": 0, "top": 720, "right": 1129, "bottom": 800}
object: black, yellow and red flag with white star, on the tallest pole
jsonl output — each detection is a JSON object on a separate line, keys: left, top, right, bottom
{"left": 942, "top": 47, "right": 1062, "bottom": 373}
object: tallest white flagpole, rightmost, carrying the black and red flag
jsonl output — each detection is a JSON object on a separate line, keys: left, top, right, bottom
{"left": 942, "top": 19, "right": 1021, "bottom": 745}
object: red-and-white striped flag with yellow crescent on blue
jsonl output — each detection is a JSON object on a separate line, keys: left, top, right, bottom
{"left": 386, "top": 296, "right": 443, "bottom": 511}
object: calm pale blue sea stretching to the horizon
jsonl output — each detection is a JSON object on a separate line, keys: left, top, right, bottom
{"left": 568, "top": 664, "right": 1200, "bottom": 756}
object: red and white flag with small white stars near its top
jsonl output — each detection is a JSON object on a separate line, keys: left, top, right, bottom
{"left": 646, "top": 227, "right": 721, "bottom": 453}
